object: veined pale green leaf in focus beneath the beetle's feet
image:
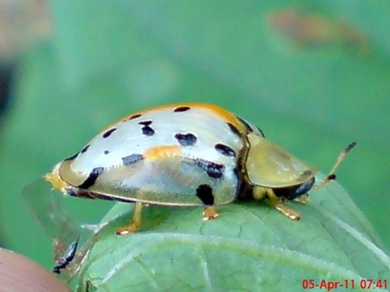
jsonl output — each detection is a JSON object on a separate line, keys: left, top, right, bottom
{"left": 74, "top": 182, "right": 390, "bottom": 291}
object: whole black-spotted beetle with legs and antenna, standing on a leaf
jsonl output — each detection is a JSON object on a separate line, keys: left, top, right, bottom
{"left": 45, "top": 103, "right": 356, "bottom": 234}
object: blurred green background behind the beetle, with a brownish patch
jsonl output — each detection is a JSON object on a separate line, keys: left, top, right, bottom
{"left": 0, "top": 0, "right": 390, "bottom": 267}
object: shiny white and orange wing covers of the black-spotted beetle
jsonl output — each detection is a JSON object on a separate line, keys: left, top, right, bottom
{"left": 54, "top": 104, "right": 262, "bottom": 206}
